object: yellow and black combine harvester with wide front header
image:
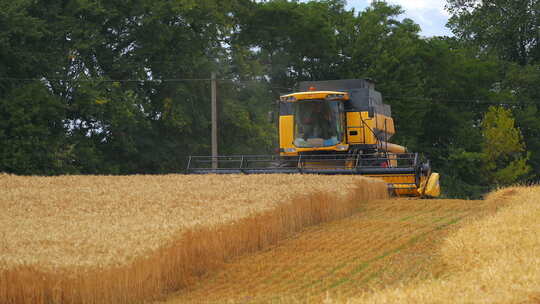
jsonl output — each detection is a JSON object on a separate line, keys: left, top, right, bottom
{"left": 187, "top": 79, "right": 440, "bottom": 197}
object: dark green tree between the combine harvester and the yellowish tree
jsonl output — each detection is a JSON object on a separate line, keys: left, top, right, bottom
{"left": 414, "top": 37, "right": 503, "bottom": 198}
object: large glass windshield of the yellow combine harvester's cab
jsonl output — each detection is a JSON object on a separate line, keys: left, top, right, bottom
{"left": 294, "top": 100, "right": 343, "bottom": 148}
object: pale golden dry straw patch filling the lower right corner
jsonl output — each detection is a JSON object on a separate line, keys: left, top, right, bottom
{"left": 346, "top": 187, "right": 540, "bottom": 303}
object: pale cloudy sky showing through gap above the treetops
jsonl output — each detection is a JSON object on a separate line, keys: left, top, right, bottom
{"left": 347, "top": 0, "right": 453, "bottom": 37}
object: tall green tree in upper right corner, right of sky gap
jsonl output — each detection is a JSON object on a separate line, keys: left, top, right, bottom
{"left": 448, "top": 0, "right": 540, "bottom": 184}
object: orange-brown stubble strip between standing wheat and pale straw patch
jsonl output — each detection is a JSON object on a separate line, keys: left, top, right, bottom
{"left": 158, "top": 199, "right": 502, "bottom": 304}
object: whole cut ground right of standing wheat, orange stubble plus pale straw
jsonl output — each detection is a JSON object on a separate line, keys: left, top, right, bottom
{"left": 161, "top": 187, "right": 540, "bottom": 304}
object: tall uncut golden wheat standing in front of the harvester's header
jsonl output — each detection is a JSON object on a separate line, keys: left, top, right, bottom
{"left": 0, "top": 174, "right": 387, "bottom": 303}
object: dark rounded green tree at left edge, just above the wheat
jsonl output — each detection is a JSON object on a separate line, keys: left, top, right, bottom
{"left": 0, "top": 82, "right": 75, "bottom": 175}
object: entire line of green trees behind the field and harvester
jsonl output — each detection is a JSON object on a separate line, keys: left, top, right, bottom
{"left": 0, "top": 0, "right": 540, "bottom": 198}
